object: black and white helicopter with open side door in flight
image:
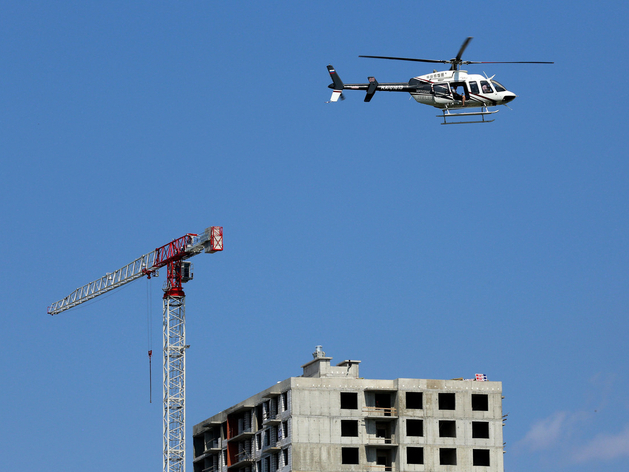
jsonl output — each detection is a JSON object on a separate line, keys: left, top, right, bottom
{"left": 328, "top": 36, "right": 554, "bottom": 125}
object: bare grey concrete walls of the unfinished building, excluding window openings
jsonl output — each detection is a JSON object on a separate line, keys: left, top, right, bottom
{"left": 193, "top": 368, "right": 504, "bottom": 472}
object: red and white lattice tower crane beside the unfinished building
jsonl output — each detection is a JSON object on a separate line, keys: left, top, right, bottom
{"left": 48, "top": 226, "right": 223, "bottom": 472}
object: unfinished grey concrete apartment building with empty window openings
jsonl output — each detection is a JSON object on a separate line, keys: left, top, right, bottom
{"left": 193, "top": 347, "right": 504, "bottom": 472}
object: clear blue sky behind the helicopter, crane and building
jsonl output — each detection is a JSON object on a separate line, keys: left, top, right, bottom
{"left": 0, "top": 1, "right": 629, "bottom": 472}
